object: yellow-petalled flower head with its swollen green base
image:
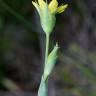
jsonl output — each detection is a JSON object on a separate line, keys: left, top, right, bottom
{"left": 32, "top": 0, "right": 68, "bottom": 33}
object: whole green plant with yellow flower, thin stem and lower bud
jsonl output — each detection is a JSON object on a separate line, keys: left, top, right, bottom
{"left": 32, "top": 0, "right": 68, "bottom": 96}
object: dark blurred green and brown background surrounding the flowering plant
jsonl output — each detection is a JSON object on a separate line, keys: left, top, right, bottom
{"left": 0, "top": 0, "right": 96, "bottom": 96}
